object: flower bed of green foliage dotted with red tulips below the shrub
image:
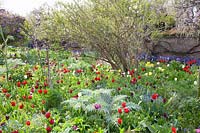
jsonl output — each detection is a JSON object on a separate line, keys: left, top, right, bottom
{"left": 0, "top": 49, "right": 200, "bottom": 133}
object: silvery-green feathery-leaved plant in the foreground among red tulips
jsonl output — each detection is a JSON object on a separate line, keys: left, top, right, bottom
{"left": 64, "top": 89, "right": 141, "bottom": 130}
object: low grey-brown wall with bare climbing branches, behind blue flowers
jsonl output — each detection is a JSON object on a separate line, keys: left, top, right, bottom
{"left": 145, "top": 37, "right": 200, "bottom": 58}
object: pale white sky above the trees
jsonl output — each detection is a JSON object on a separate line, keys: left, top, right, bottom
{"left": 0, "top": 0, "right": 73, "bottom": 17}
